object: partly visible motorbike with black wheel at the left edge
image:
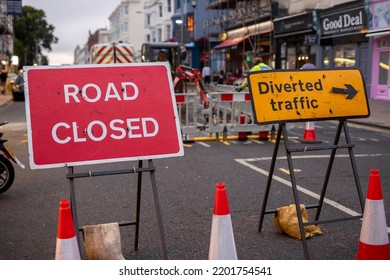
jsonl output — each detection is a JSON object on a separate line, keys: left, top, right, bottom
{"left": 0, "top": 121, "right": 25, "bottom": 194}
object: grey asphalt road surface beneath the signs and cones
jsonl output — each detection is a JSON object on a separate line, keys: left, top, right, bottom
{"left": 0, "top": 102, "right": 390, "bottom": 260}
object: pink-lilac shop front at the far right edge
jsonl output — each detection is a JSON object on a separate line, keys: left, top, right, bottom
{"left": 367, "top": 0, "right": 390, "bottom": 101}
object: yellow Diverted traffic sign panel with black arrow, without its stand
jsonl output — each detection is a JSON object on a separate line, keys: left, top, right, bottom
{"left": 248, "top": 69, "right": 370, "bottom": 124}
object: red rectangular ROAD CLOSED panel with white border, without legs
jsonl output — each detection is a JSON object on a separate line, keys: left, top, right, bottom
{"left": 25, "top": 63, "right": 183, "bottom": 169}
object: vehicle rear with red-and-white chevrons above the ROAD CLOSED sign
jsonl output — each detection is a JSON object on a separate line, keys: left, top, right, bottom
{"left": 89, "top": 43, "right": 135, "bottom": 64}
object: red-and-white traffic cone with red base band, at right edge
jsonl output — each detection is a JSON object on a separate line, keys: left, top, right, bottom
{"left": 356, "top": 169, "right": 390, "bottom": 260}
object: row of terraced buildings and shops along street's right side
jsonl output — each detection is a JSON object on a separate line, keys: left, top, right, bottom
{"left": 70, "top": 0, "right": 390, "bottom": 100}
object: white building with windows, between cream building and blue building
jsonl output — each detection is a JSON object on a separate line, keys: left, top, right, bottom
{"left": 143, "top": 0, "right": 175, "bottom": 43}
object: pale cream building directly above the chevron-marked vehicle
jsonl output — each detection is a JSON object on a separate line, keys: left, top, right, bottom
{"left": 109, "top": 0, "right": 144, "bottom": 51}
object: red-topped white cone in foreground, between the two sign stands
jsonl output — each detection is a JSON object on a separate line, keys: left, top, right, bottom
{"left": 209, "top": 182, "right": 237, "bottom": 260}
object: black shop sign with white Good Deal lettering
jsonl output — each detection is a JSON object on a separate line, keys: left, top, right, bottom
{"left": 321, "top": 8, "right": 367, "bottom": 37}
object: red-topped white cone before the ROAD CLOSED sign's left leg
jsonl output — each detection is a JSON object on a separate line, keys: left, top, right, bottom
{"left": 56, "top": 200, "right": 81, "bottom": 260}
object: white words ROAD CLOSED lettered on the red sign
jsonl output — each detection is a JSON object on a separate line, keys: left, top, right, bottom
{"left": 51, "top": 82, "right": 159, "bottom": 144}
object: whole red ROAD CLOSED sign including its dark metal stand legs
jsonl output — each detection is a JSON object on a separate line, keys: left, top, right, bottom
{"left": 25, "top": 63, "right": 184, "bottom": 259}
